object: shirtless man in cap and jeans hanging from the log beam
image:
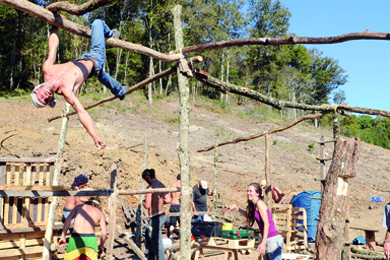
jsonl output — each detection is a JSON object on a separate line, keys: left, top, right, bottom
{"left": 31, "top": 16, "right": 126, "bottom": 149}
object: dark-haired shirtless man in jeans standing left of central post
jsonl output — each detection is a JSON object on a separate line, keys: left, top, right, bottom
{"left": 142, "top": 169, "right": 172, "bottom": 260}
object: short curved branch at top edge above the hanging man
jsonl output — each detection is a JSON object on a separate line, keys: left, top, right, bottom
{"left": 47, "top": 0, "right": 120, "bottom": 15}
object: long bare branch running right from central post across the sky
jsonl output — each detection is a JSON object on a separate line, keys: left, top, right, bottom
{"left": 175, "top": 30, "right": 390, "bottom": 53}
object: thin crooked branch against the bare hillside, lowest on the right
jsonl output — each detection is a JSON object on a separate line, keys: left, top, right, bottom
{"left": 197, "top": 111, "right": 331, "bottom": 153}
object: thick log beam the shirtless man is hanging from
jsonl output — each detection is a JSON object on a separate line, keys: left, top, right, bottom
{"left": 0, "top": 0, "right": 181, "bottom": 63}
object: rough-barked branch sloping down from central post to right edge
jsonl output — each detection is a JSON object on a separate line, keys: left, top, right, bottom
{"left": 195, "top": 72, "right": 390, "bottom": 117}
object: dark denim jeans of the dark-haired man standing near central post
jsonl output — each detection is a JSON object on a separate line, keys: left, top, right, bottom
{"left": 145, "top": 213, "right": 166, "bottom": 260}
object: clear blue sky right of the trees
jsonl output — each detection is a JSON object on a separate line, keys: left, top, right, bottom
{"left": 281, "top": 0, "right": 390, "bottom": 111}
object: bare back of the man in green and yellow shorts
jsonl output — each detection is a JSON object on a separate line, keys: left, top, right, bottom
{"left": 73, "top": 204, "right": 104, "bottom": 234}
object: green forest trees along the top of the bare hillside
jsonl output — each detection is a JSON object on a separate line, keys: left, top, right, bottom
{"left": 0, "top": 0, "right": 390, "bottom": 149}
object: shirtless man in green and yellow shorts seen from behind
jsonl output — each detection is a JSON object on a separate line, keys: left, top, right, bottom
{"left": 58, "top": 198, "right": 107, "bottom": 260}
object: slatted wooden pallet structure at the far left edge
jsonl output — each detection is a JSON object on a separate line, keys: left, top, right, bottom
{"left": 0, "top": 158, "right": 55, "bottom": 260}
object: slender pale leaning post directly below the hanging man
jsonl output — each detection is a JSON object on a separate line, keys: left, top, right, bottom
{"left": 42, "top": 103, "right": 69, "bottom": 260}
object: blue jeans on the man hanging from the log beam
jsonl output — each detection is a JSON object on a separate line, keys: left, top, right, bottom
{"left": 81, "top": 19, "right": 126, "bottom": 100}
